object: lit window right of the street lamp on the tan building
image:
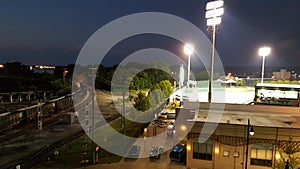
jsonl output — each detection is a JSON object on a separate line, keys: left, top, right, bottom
{"left": 250, "top": 144, "right": 273, "bottom": 167}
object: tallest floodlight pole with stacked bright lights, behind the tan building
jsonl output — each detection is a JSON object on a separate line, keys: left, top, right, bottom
{"left": 205, "top": 0, "right": 224, "bottom": 102}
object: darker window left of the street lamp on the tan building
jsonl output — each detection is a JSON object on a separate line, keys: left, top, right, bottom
{"left": 193, "top": 138, "right": 213, "bottom": 160}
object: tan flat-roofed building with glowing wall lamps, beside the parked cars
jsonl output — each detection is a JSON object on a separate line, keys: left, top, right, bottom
{"left": 175, "top": 102, "right": 300, "bottom": 169}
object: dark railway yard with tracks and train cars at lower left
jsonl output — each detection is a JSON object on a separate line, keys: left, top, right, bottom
{"left": 0, "top": 91, "right": 119, "bottom": 169}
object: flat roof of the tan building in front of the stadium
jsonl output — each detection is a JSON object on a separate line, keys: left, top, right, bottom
{"left": 183, "top": 102, "right": 300, "bottom": 128}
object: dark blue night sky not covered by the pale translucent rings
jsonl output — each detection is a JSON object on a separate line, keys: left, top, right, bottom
{"left": 0, "top": 0, "right": 300, "bottom": 66}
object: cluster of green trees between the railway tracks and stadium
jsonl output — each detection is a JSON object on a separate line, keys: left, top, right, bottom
{"left": 95, "top": 62, "right": 174, "bottom": 111}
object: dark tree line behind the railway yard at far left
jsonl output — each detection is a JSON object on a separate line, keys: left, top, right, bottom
{"left": 0, "top": 62, "right": 74, "bottom": 95}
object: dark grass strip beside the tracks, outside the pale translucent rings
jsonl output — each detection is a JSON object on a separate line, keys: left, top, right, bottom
{"left": 42, "top": 113, "right": 148, "bottom": 168}
